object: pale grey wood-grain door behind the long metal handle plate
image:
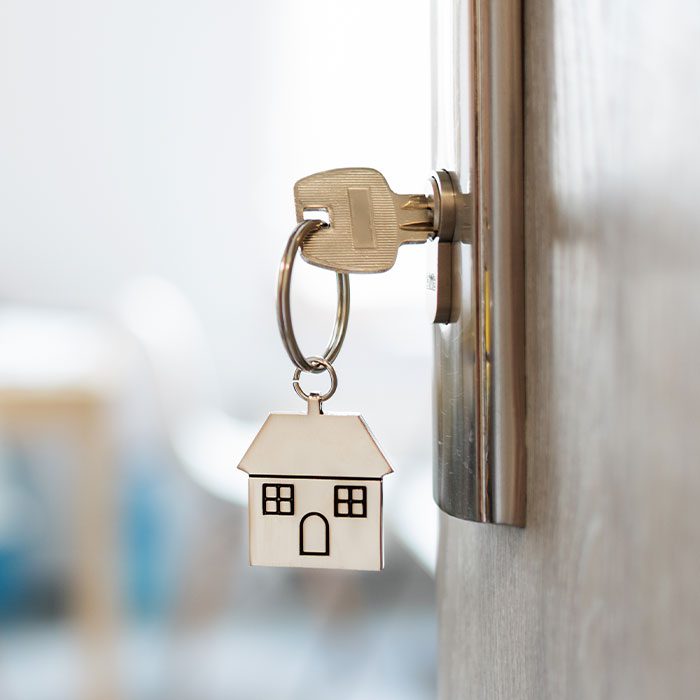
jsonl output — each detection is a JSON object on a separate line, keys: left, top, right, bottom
{"left": 433, "top": 0, "right": 700, "bottom": 700}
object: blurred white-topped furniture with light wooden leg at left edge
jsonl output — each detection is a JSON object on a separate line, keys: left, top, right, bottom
{"left": 0, "top": 306, "right": 126, "bottom": 700}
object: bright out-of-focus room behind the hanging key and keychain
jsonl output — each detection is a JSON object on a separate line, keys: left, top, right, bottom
{"left": 0, "top": 0, "right": 436, "bottom": 700}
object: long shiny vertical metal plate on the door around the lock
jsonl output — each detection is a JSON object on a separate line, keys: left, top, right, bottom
{"left": 433, "top": 0, "right": 525, "bottom": 526}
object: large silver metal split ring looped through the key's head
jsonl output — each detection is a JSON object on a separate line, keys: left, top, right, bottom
{"left": 277, "top": 219, "right": 350, "bottom": 372}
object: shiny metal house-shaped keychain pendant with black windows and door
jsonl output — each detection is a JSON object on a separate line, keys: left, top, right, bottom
{"left": 238, "top": 395, "right": 392, "bottom": 570}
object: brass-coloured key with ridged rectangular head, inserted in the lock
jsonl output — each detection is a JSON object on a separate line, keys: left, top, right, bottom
{"left": 294, "top": 168, "right": 435, "bottom": 272}
